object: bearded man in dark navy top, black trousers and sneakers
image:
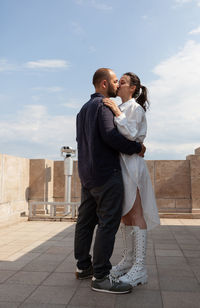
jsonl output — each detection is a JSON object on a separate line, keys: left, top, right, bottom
{"left": 75, "top": 68, "right": 145, "bottom": 293}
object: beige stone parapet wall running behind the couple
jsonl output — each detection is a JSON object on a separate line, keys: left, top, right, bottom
{"left": 0, "top": 148, "right": 200, "bottom": 224}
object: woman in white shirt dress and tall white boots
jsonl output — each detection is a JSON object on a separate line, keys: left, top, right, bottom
{"left": 104, "top": 73, "right": 160, "bottom": 286}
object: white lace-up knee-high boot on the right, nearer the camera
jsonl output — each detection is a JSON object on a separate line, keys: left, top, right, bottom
{"left": 120, "top": 227, "right": 148, "bottom": 287}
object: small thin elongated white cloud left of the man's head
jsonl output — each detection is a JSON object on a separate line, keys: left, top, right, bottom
{"left": 25, "top": 59, "right": 69, "bottom": 69}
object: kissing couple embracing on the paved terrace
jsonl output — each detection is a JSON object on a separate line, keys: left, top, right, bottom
{"left": 74, "top": 68, "right": 159, "bottom": 294}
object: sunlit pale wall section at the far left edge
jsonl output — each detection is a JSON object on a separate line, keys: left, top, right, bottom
{"left": 0, "top": 154, "right": 29, "bottom": 226}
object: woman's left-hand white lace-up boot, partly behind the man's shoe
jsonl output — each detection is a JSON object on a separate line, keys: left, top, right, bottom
{"left": 110, "top": 223, "right": 134, "bottom": 278}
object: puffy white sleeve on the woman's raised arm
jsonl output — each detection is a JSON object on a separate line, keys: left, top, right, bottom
{"left": 114, "top": 104, "right": 143, "bottom": 141}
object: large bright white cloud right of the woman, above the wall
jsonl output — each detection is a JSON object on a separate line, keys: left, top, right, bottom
{"left": 147, "top": 41, "right": 200, "bottom": 159}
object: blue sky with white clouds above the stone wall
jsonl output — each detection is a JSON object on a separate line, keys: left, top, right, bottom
{"left": 0, "top": 0, "right": 200, "bottom": 160}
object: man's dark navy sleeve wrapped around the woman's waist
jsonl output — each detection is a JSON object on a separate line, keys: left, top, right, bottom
{"left": 98, "top": 105, "right": 142, "bottom": 155}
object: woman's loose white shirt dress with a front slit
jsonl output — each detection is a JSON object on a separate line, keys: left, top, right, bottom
{"left": 114, "top": 98, "right": 160, "bottom": 230}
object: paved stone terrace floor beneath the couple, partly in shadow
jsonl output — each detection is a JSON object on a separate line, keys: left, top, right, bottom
{"left": 0, "top": 219, "right": 200, "bottom": 308}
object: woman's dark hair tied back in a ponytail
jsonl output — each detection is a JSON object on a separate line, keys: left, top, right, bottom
{"left": 124, "top": 72, "right": 149, "bottom": 111}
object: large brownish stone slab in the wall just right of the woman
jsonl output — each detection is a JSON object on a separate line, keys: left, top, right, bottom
{"left": 155, "top": 160, "right": 191, "bottom": 199}
